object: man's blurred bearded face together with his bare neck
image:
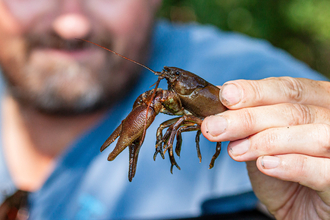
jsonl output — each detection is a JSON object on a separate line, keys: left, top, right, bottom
{"left": 0, "top": 0, "right": 161, "bottom": 191}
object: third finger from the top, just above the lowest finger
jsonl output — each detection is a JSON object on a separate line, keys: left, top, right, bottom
{"left": 228, "top": 124, "right": 330, "bottom": 161}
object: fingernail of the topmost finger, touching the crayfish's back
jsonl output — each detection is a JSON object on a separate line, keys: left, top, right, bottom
{"left": 220, "top": 83, "right": 242, "bottom": 106}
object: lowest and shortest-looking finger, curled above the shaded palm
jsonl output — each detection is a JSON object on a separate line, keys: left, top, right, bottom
{"left": 257, "top": 154, "right": 330, "bottom": 205}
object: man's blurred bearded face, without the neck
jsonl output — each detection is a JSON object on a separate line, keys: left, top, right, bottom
{"left": 0, "top": 0, "right": 160, "bottom": 114}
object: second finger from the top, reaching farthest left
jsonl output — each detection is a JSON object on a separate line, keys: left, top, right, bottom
{"left": 201, "top": 103, "right": 330, "bottom": 141}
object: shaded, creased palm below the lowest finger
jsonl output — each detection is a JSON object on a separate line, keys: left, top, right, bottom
{"left": 247, "top": 161, "right": 330, "bottom": 219}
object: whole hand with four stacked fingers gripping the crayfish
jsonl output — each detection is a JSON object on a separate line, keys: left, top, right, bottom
{"left": 202, "top": 77, "right": 330, "bottom": 219}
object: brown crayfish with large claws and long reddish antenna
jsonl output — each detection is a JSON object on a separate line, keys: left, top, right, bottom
{"left": 84, "top": 40, "right": 227, "bottom": 181}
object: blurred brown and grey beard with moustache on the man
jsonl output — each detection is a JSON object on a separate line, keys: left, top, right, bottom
{"left": 0, "top": 32, "right": 146, "bottom": 115}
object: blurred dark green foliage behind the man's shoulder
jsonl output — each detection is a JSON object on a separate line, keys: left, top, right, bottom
{"left": 159, "top": 0, "right": 330, "bottom": 77}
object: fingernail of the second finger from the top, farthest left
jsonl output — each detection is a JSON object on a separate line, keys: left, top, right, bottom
{"left": 205, "top": 115, "right": 228, "bottom": 137}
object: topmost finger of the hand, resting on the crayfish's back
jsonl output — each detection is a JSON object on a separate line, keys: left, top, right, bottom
{"left": 220, "top": 77, "right": 330, "bottom": 109}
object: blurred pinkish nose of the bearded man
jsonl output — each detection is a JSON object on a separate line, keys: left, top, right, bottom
{"left": 53, "top": 0, "right": 91, "bottom": 39}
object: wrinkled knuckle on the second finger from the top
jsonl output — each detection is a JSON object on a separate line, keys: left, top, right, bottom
{"left": 288, "top": 104, "right": 314, "bottom": 125}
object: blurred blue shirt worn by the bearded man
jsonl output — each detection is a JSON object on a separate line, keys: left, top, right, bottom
{"left": 0, "top": 21, "right": 325, "bottom": 220}
